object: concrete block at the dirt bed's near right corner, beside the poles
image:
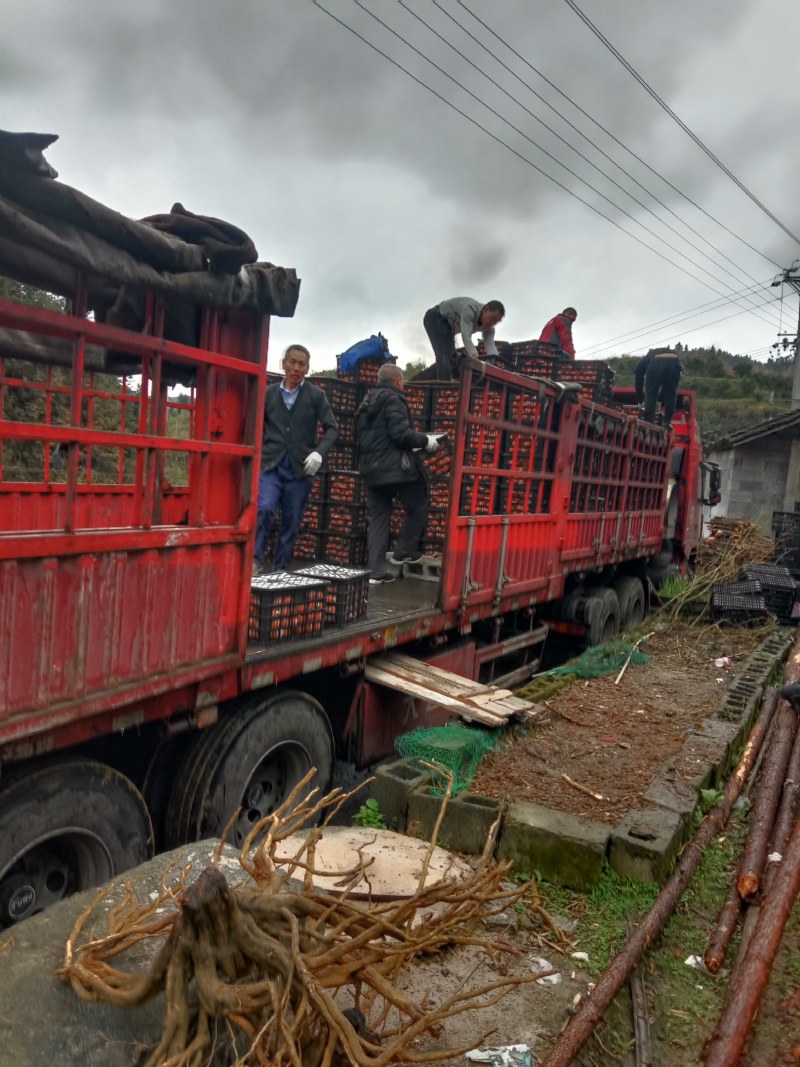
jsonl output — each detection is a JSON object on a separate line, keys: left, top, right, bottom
{"left": 608, "top": 809, "right": 683, "bottom": 886}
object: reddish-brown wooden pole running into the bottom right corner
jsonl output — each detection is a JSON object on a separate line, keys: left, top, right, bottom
{"left": 703, "top": 821, "right": 800, "bottom": 1067}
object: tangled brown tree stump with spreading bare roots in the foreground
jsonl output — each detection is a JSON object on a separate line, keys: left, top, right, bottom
{"left": 59, "top": 776, "right": 542, "bottom": 1067}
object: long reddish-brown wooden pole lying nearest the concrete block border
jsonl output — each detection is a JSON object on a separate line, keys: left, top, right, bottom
{"left": 542, "top": 689, "right": 780, "bottom": 1067}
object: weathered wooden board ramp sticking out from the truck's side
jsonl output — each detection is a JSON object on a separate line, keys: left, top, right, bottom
{"left": 364, "top": 652, "right": 542, "bottom": 727}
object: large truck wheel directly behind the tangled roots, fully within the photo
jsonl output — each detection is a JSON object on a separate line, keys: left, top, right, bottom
{"left": 166, "top": 692, "right": 334, "bottom": 847}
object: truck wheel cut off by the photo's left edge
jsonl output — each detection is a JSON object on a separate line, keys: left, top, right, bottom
{"left": 0, "top": 760, "right": 153, "bottom": 926}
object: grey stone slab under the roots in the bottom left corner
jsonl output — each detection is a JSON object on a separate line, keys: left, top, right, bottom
{"left": 0, "top": 841, "right": 249, "bottom": 1067}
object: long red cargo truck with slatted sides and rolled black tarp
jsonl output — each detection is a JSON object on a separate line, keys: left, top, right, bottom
{"left": 0, "top": 157, "right": 701, "bottom": 924}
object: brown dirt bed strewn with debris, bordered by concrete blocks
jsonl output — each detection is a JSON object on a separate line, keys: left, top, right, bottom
{"left": 471, "top": 626, "right": 764, "bottom": 824}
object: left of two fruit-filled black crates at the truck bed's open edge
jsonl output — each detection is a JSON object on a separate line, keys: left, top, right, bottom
{"left": 247, "top": 572, "right": 329, "bottom": 644}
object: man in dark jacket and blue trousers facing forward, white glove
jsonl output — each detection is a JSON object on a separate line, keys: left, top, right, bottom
{"left": 253, "top": 345, "right": 339, "bottom": 575}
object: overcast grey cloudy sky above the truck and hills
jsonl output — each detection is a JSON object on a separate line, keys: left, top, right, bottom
{"left": 0, "top": 0, "right": 800, "bottom": 368}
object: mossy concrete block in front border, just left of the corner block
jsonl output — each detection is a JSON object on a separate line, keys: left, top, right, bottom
{"left": 497, "top": 802, "right": 612, "bottom": 890}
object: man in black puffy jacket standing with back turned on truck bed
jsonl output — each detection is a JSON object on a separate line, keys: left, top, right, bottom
{"left": 356, "top": 363, "right": 438, "bottom": 585}
